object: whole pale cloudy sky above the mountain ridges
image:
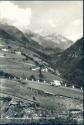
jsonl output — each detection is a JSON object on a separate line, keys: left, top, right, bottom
{"left": 0, "top": 1, "right": 83, "bottom": 42}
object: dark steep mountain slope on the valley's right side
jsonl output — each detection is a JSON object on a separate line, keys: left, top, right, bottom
{"left": 52, "top": 38, "right": 84, "bottom": 86}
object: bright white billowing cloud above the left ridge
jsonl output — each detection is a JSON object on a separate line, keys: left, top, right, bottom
{"left": 0, "top": 1, "right": 32, "bottom": 28}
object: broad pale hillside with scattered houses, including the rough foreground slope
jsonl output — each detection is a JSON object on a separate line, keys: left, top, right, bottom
{"left": 0, "top": 25, "right": 83, "bottom": 125}
